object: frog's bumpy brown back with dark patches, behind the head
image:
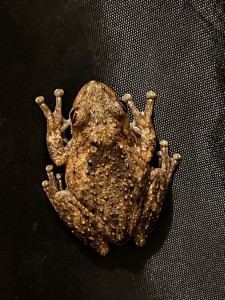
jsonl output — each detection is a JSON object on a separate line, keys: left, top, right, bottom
{"left": 66, "top": 143, "right": 149, "bottom": 242}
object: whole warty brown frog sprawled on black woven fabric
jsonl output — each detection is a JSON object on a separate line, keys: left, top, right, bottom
{"left": 35, "top": 80, "right": 181, "bottom": 256}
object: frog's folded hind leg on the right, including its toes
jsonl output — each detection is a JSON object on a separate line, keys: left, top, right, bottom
{"left": 134, "top": 140, "right": 181, "bottom": 246}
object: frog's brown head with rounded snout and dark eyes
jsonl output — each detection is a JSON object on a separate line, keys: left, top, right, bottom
{"left": 70, "top": 81, "right": 130, "bottom": 140}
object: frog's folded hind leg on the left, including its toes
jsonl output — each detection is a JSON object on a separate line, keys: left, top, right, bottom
{"left": 42, "top": 165, "right": 109, "bottom": 256}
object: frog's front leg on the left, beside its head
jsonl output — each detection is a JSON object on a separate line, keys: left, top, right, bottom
{"left": 35, "top": 89, "right": 69, "bottom": 166}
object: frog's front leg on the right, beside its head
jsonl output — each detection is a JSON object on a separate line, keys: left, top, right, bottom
{"left": 122, "top": 91, "right": 156, "bottom": 162}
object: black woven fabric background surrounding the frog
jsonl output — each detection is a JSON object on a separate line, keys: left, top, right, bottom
{"left": 0, "top": 0, "right": 225, "bottom": 300}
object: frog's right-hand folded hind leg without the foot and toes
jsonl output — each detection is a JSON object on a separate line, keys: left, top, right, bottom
{"left": 134, "top": 168, "right": 167, "bottom": 246}
